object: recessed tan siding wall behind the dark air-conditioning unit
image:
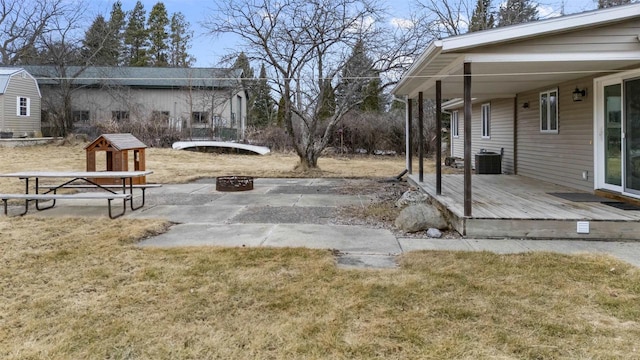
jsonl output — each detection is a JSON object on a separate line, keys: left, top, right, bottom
{"left": 452, "top": 99, "right": 514, "bottom": 174}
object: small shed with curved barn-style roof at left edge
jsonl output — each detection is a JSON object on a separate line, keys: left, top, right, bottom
{"left": 0, "top": 68, "right": 41, "bottom": 137}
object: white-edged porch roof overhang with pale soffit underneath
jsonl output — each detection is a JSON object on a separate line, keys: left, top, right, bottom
{"left": 392, "top": 3, "right": 640, "bottom": 98}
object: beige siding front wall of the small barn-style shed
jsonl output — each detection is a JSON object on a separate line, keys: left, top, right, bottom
{"left": 2, "top": 73, "right": 41, "bottom": 137}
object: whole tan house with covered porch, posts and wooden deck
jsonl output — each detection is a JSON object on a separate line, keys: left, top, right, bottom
{"left": 393, "top": 4, "right": 640, "bottom": 239}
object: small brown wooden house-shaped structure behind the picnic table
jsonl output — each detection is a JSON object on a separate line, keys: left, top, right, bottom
{"left": 85, "top": 134, "right": 147, "bottom": 185}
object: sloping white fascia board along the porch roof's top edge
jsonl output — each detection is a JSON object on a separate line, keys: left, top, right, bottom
{"left": 442, "top": 3, "right": 640, "bottom": 52}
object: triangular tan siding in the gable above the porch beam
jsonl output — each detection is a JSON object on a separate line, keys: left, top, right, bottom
{"left": 478, "top": 20, "right": 640, "bottom": 53}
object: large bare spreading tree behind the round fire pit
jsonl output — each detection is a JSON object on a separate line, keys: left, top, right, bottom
{"left": 204, "top": 0, "right": 429, "bottom": 168}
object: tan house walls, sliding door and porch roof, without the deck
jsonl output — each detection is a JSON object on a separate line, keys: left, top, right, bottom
{"left": 393, "top": 4, "right": 640, "bottom": 202}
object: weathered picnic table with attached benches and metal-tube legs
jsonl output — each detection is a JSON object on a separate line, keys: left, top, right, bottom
{"left": 0, "top": 170, "right": 160, "bottom": 219}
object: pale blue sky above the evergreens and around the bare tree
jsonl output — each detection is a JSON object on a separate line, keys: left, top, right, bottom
{"left": 87, "top": 0, "right": 597, "bottom": 67}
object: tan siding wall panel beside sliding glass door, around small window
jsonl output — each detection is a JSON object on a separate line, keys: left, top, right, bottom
{"left": 517, "top": 78, "right": 594, "bottom": 191}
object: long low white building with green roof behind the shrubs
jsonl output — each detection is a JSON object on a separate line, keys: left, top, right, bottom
{"left": 25, "top": 66, "right": 247, "bottom": 139}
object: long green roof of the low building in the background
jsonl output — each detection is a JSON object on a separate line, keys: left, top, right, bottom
{"left": 24, "top": 65, "right": 242, "bottom": 89}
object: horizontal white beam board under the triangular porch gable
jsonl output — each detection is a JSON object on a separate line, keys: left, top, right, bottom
{"left": 464, "top": 51, "right": 640, "bottom": 63}
